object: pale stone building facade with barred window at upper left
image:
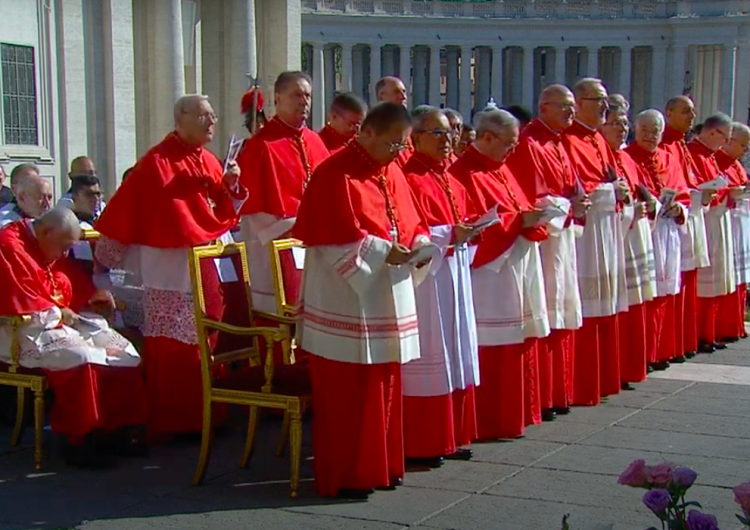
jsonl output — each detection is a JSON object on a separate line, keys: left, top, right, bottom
{"left": 0, "top": 0, "right": 301, "bottom": 197}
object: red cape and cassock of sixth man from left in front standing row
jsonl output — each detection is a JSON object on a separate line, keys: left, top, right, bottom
{"left": 614, "top": 151, "right": 648, "bottom": 383}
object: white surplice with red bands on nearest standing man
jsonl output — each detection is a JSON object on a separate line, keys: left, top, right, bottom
{"left": 297, "top": 235, "right": 429, "bottom": 364}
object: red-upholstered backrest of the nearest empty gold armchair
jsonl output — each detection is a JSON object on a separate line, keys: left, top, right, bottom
{"left": 189, "top": 243, "right": 259, "bottom": 375}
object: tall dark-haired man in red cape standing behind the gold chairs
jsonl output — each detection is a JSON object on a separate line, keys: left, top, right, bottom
{"left": 237, "top": 72, "right": 329, "bottom": 348}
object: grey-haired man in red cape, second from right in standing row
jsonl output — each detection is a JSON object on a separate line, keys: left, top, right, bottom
{"left": 688, "top": 114, "right": 737, "bottom": 352}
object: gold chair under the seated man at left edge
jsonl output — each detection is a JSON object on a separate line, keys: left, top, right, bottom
{"left": 0, "top": 316, "right": 47, "bottom": 470}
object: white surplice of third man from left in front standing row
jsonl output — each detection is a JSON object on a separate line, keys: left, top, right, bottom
{"left": 471, "top": 236, "right": 550, "bottom": 346}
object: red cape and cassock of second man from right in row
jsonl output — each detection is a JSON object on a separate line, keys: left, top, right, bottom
{"left": 687, "top": 139, "right": 733, "bottom": 344}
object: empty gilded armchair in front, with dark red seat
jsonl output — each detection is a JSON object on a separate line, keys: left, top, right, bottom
{"left": 189, "top": 239, "right": 311, "bottom": 497}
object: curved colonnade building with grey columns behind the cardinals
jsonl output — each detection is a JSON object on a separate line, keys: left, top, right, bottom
{"left": 302, "top": 0, "right": 750, "bottom": 127}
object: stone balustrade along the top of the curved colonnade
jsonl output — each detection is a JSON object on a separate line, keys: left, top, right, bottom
{"left": 302, "top": 0, "right": 750, "bottom": 19}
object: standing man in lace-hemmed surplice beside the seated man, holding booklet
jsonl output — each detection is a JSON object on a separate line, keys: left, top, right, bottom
{"left": 96, "top": 95, "right": 247, "bottom": 439}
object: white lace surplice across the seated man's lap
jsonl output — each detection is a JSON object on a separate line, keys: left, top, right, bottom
{"left": 0, "top": 307, "right": 140, "bottom": 370}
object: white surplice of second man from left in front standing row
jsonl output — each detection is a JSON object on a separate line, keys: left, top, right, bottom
{"left": 402, "top": 225, "right": 479, "bottom": 397}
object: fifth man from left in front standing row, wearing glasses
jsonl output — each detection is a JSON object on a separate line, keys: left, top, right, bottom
{"left": 563, "top": 78, "right": 632, "bottom": 405}
